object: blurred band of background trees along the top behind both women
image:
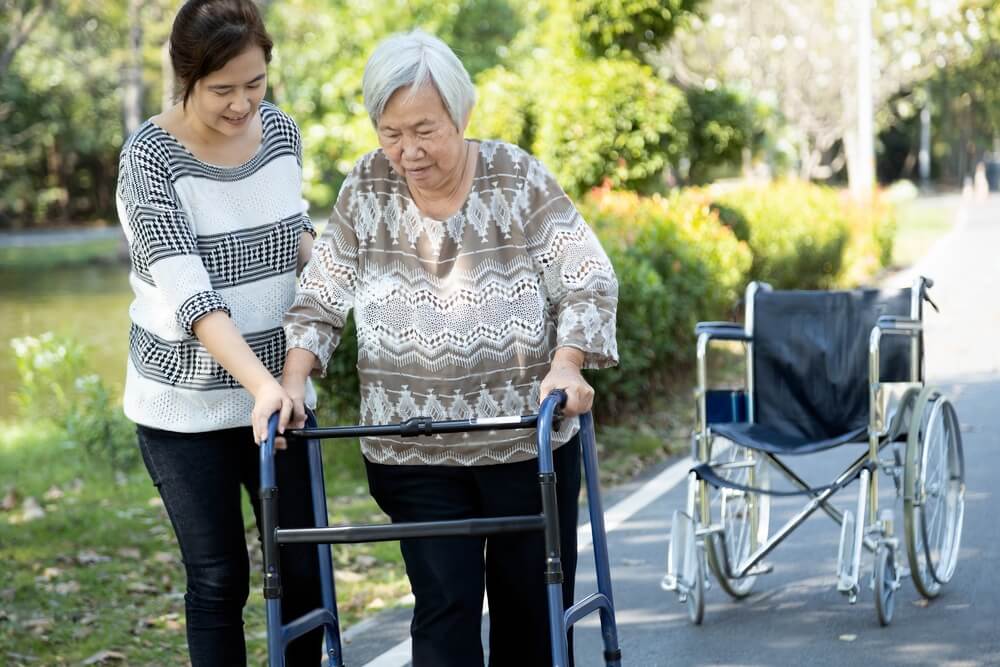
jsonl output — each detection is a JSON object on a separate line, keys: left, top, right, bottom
{"left": 0, "top": 0, "right": 1000, "bottom": 230}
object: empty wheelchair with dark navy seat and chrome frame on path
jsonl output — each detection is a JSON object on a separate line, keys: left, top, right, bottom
{"left": 661, "top": 277, "right": 965, "bottom": 626}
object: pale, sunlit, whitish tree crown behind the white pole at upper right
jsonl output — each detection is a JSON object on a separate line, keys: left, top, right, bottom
{"left": 653, "top": 0, "right": 977, "bottom": 187}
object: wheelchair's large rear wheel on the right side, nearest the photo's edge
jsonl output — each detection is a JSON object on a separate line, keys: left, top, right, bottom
{"left": 903, "top": 388, "right": 965, "bottom": 598}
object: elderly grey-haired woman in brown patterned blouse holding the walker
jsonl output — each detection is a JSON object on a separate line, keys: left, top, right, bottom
{"left": 270, "top": 31, "right": 618, "bottom": 667}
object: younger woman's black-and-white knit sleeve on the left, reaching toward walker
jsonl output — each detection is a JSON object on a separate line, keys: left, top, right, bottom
{"left": 117, "top": 136, "right": 231, "bottom": 336}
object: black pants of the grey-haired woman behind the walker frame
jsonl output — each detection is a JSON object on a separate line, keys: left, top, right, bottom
{"left": 366, "top": 438, "right": 580, "bottom": 667}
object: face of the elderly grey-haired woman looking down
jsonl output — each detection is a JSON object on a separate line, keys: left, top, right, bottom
{"left": 378, "top": 85, "right": 465, "bottom": 192}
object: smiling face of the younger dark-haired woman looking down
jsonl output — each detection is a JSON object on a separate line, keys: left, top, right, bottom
{"left": 187, "top": 46, "right": 267, "bottom": 138}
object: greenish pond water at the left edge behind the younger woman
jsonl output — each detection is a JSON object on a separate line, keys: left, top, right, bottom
{"left": 0, "top": 264, "right": 132, "bottom": 418}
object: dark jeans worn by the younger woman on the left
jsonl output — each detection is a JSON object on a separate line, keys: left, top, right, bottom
{"left": 137, "top": 426, "right": 323, "bottom": 667}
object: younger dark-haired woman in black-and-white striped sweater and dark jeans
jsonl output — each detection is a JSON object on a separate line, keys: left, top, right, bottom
{"left": 117, "top": 0, "right": 321, "bottom": 667}
